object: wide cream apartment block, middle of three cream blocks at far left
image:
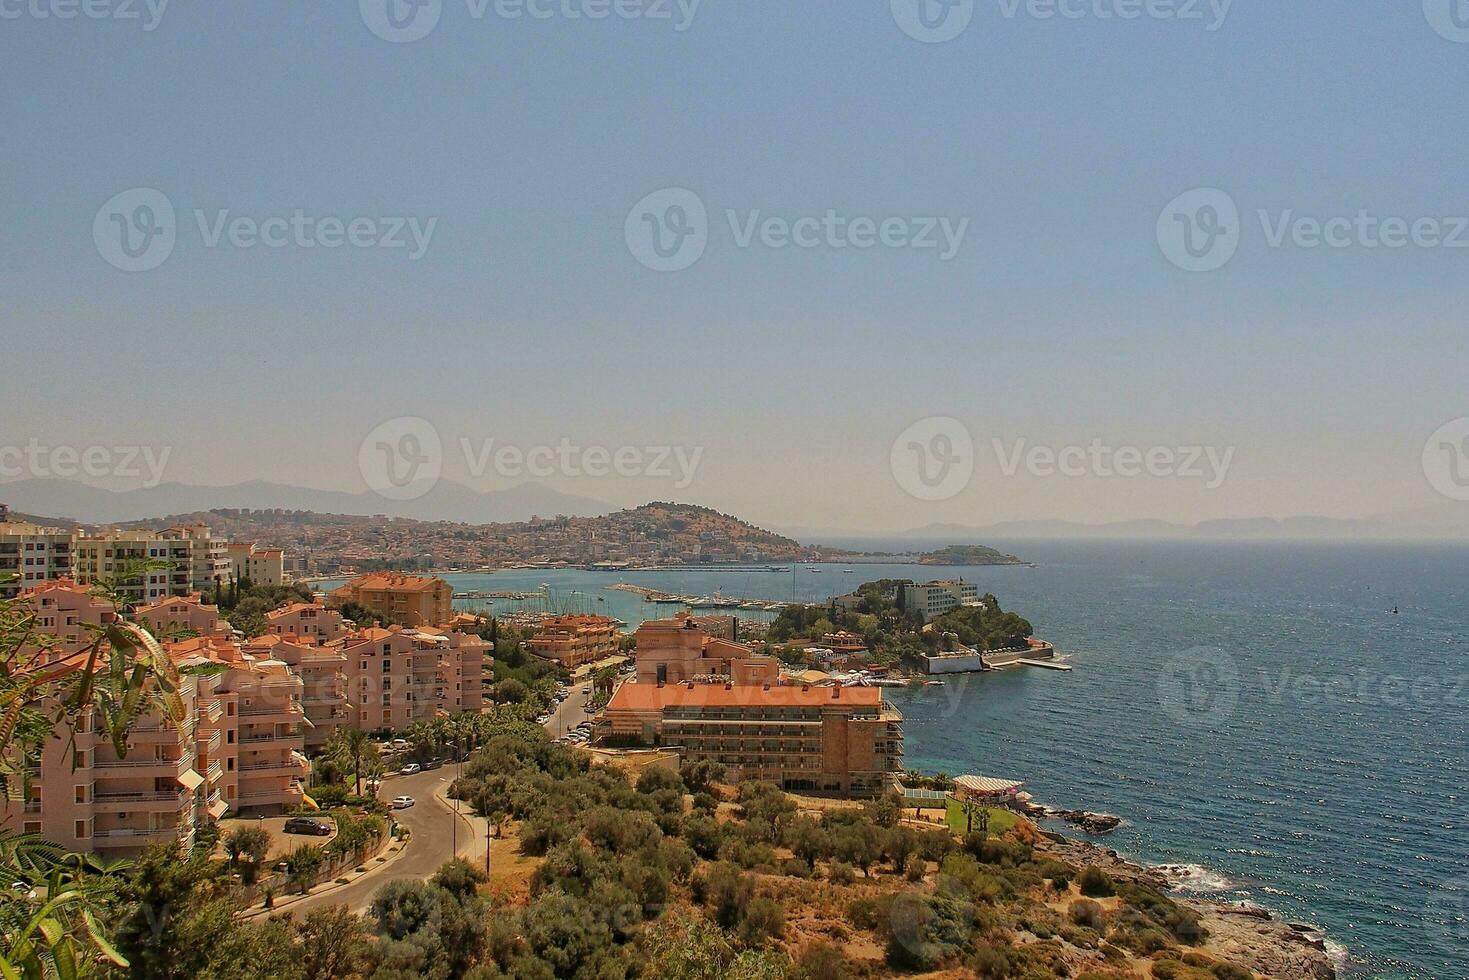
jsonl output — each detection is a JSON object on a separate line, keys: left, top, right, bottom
{"left": 73, "top": 525, "right": 231, "bottom": 602}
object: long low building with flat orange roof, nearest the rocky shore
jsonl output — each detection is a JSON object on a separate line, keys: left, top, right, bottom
{"left": 596, "top": 680, "right": 903, "bottom": 798}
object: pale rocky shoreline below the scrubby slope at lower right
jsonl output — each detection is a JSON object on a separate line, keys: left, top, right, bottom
{"left": 1044, "top": 832, "right": 1337, "bottom": 980}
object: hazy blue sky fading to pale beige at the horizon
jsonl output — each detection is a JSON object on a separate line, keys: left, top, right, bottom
{"left": 0, "top": 0, "right": 1469, "bottom": 530}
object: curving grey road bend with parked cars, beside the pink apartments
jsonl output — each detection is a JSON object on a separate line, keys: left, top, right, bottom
{"left": 281, "top": 765, "right": 485, "bottom": 914}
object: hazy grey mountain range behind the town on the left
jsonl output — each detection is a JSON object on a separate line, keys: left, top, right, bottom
{"left": 0, "top": 479, "right": 616, "bottom": 525}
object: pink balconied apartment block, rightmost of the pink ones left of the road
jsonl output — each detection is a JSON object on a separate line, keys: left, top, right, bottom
{"left": 342, "top": 626, "right": 492, "bottom": 732}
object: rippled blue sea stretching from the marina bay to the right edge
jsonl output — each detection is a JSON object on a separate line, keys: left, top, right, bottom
{"left": 327, "top": 541, "right": 1469, "bottom": 980}
